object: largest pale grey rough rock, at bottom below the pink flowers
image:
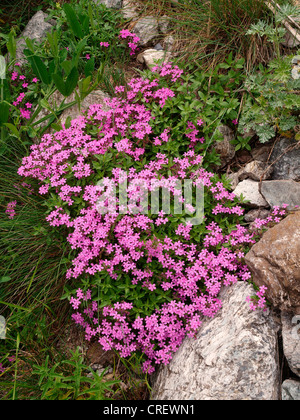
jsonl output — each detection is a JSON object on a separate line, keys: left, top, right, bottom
{"left": 151, "top": 282, "right": 280, "bottom": 400}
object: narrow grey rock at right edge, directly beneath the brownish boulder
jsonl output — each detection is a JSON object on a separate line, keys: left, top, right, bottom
{"left": 281, "top": 311, "right": 300, "bottom": 376}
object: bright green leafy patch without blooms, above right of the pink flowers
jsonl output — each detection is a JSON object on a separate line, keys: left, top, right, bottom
{"left": 139, "top": 54, "right": 245, "bottom": 168}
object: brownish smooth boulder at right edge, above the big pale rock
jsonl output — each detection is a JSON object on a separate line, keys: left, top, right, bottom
{"left": 245, "top": 211, "right": 300, "bottom": 314}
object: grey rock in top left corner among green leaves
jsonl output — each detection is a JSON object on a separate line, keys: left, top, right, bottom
{"left": 16, "top": 10, "right": 53, "bottom": 64}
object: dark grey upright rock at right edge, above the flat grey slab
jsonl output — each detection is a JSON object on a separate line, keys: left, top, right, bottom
{"left": 270, "top": 137, "right": 300, "bottom": 181}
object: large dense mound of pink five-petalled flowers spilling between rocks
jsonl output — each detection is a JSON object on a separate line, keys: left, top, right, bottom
{"left": 18, "top": 62, "right": 290, "bottom": 373}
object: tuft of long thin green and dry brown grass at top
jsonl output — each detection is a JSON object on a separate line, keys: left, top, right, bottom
{"left": 143, "top": 0, "right": 292, "bottom": 69}
